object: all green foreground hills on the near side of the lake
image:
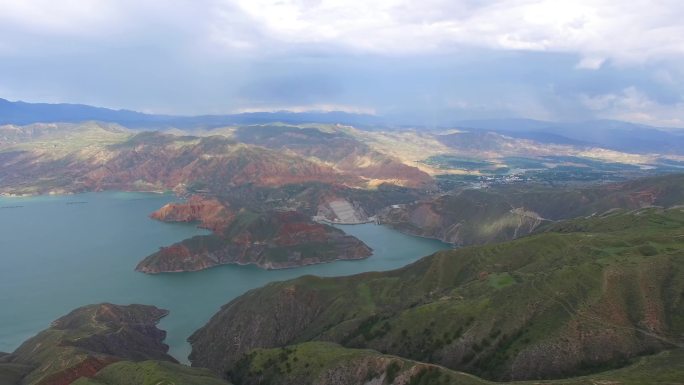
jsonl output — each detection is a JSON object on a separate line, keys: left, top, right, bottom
{"left": 0, "top": 202, "right": 684, "bottom": 385}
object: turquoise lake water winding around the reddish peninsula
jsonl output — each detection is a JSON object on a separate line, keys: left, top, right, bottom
{"left": 0, "top": 192, "right": 448, "bottom": 361}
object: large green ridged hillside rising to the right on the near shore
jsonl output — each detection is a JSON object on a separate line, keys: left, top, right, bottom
{"left": 190, "top": 208, "right": 684, "bottom": 380}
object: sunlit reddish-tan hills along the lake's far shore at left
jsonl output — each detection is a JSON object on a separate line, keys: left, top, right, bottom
{"left": 0, "top": 132, "right": 362, "bottom": 194}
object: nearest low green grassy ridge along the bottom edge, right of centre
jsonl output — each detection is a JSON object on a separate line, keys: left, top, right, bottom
{"left": 228, "top": 342, "right": 684, "bottom": 385}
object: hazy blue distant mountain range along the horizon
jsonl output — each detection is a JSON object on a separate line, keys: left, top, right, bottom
{"left": 0, "top": 99, "right": 684, "bottom": 155}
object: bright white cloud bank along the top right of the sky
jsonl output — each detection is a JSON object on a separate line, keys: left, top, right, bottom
{"left": 220, "top": 0, "right": 684, "bottom": 63}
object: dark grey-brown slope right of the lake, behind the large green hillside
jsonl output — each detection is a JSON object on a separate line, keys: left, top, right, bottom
{"left": 378, "top": 174, "right": 684, "bottom": 246}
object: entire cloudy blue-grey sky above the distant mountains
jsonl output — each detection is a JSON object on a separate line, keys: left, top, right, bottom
{"left": 0, "top": 0, "right": 684, "bottom": 127}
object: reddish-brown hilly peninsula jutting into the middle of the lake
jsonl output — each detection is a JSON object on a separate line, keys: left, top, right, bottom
{"left": 136, "top": 209, "right": 371, "bottom": 274}
